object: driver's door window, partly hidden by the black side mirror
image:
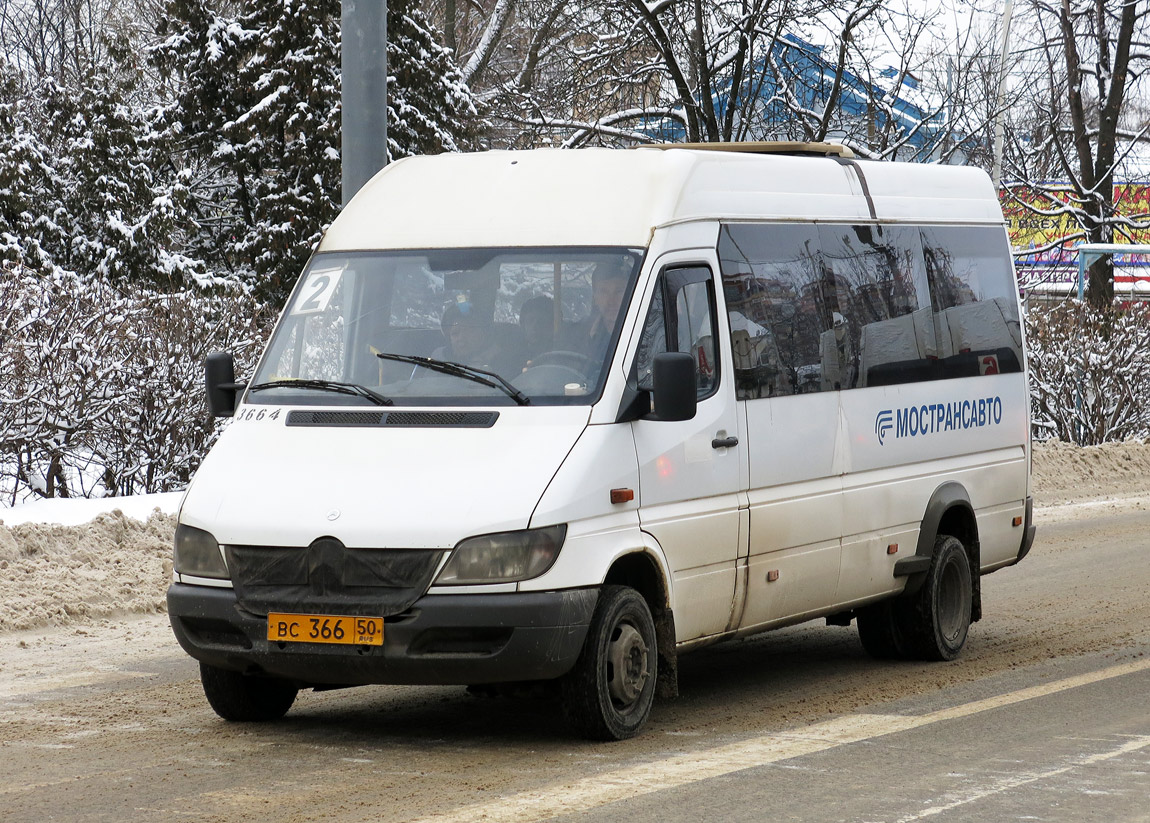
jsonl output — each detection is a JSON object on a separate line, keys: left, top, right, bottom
{"left": 635, "top": 267, "right": 719, "bottom": 400}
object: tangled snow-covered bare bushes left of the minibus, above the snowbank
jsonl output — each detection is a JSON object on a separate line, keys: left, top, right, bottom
{"left": 0, "top": 267, "right": 271, "bottom": 503}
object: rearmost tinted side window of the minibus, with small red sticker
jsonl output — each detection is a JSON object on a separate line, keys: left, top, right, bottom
{"left": 921, "top": 226, "right": 1024, "bottom": 377}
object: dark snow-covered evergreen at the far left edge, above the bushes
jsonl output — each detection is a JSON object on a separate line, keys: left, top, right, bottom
{"left": 0, "top": 41, "right": 197, "bottom": 287}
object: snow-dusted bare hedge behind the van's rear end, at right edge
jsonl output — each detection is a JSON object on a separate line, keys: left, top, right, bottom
{"left": 1026, "top": 300, "right": 1150, "bottom": 446}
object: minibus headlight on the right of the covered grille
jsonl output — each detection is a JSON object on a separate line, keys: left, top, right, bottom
{"left": 436, "top": 524, "right": 567, "bottom": 586}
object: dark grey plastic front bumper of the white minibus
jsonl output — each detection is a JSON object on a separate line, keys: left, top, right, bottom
{"left": 168, "top": 583, "right": 599, "bottom": 686}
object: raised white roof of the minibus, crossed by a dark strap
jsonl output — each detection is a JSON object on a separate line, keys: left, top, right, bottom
{"left": 320, "top": 147, "right": 1003, "bottom": 251}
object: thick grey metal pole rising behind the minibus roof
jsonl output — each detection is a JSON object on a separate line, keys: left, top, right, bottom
{"left": 339, "top": 0, "right": 388, "bottom": 206}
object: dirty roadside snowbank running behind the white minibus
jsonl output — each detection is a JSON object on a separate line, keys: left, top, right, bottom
{"left": 0, "top": 441, "right": 1150, "bottom": 632}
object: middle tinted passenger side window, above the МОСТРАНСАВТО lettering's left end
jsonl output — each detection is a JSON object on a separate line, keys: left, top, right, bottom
{"left": 819, "top": 224, "right": 937, "bottom": 389}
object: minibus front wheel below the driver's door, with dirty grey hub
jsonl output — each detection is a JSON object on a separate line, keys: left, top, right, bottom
{"left": 561, "top": 586, "right": 659, "bottom": 740}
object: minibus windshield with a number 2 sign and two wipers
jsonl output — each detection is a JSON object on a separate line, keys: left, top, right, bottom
{"left": 247, "top": 247, "right": 643, "bottom": 406}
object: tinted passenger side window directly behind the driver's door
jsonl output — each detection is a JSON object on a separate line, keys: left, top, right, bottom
{"left": 719, "top": 223, "right": 838, "bottom": 400}
